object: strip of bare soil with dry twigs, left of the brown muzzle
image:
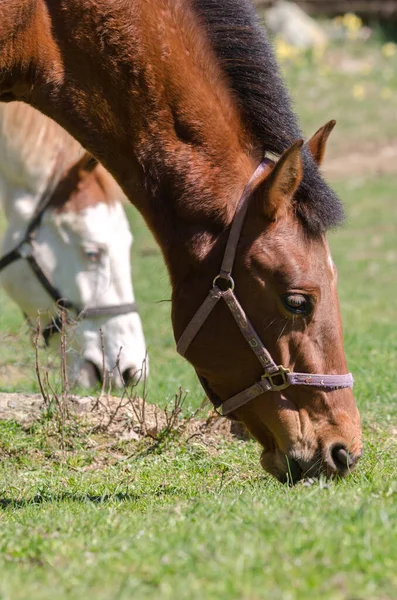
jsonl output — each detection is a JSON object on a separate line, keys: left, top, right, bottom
{"left": 0, "top": 393, "right": 249, "bottom": 442}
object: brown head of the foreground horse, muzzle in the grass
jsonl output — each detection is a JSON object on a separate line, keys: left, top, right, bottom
{"left": 175, "top": 122, "right": 361, "bottom": 481}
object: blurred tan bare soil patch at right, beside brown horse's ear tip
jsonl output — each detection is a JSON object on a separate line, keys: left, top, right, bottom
{"left": 324, "top": 141, "right": 397, "bottom": 177}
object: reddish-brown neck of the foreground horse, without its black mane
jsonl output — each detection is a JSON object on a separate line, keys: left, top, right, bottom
{"left": 28, "top": 0, "right": 258, "bottom": 284}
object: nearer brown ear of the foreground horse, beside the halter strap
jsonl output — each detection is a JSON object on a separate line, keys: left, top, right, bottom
{"left": 265, "top": 140, "right": 303, "bottom": 220}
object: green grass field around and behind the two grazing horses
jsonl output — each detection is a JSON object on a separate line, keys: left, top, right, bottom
{"left": 0, "top": 35, "right": 397, "bottom": 600}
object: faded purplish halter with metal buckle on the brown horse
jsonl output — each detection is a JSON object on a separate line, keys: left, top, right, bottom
{"left": 177, "top": 159, "right": 353, "bottom": 416}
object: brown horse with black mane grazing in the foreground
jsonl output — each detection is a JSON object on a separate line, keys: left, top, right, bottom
{"left": 0, "top": 0, "right": 361, "bottom": 481}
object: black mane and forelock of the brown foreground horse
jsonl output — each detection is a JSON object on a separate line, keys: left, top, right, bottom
{"left": 192, "top": 0, "right": 344, "bottom": 233}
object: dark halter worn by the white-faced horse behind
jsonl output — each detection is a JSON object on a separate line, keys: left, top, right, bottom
{"left": 0, "top": 154, "right": 137, "bottom": 344}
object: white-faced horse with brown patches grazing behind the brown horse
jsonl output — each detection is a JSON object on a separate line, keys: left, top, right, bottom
{"left": 0, "top": 103, "right": 146, "bottom": 387}
